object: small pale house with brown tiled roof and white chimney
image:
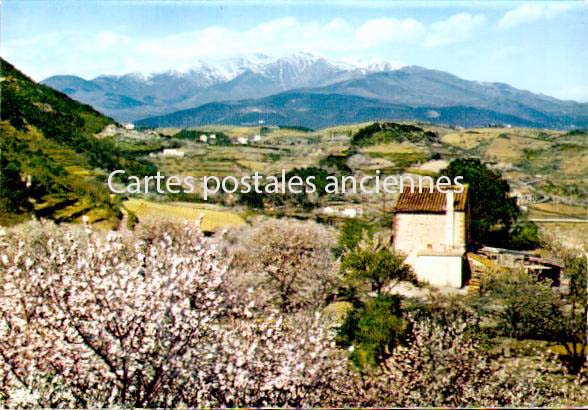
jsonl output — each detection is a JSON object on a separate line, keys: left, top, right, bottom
{"left": 393, "top": 186, "right": 470, "bottom": 288}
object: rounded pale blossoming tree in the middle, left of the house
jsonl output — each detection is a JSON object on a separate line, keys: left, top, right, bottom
{"left": 227, "top": 219, "right": 339, "bottom": 311}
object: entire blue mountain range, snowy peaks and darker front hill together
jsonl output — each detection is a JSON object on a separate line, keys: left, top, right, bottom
{"left": 43, "top": 53, "right": 588, "bottom": 128}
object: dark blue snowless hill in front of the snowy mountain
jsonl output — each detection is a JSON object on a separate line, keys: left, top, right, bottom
{"left": 136, "top": 91, "right": 588, "bottom": 129}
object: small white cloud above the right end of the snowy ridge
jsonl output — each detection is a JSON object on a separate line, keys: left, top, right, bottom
{"left": 425, "top": 13, "right": 486, "bottom": 47}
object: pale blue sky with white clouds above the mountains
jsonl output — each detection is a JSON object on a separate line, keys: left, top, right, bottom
{"left": 0, "top": 0, "right": 588, "bottom": 102}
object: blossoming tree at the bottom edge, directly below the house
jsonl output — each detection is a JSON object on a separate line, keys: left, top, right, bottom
{"left": 364, "top": 319, "right": 562, "bottom": 407}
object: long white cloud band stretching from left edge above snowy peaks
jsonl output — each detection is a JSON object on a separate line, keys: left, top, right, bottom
{"left": 1, "top": 13, "right": 485, "bottom": 79}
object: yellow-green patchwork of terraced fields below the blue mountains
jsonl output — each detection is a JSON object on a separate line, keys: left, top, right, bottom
{"left": 139, "top": 123, "right": 588, "bottom": 219}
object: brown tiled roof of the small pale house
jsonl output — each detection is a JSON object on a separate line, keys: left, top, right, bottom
{"left": 394, "top": 185, "right": 468, "bottom": 213}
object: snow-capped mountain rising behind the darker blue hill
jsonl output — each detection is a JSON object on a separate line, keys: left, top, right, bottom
{"left": 43, "top": 52, "right": 408, "bottom": 121}
